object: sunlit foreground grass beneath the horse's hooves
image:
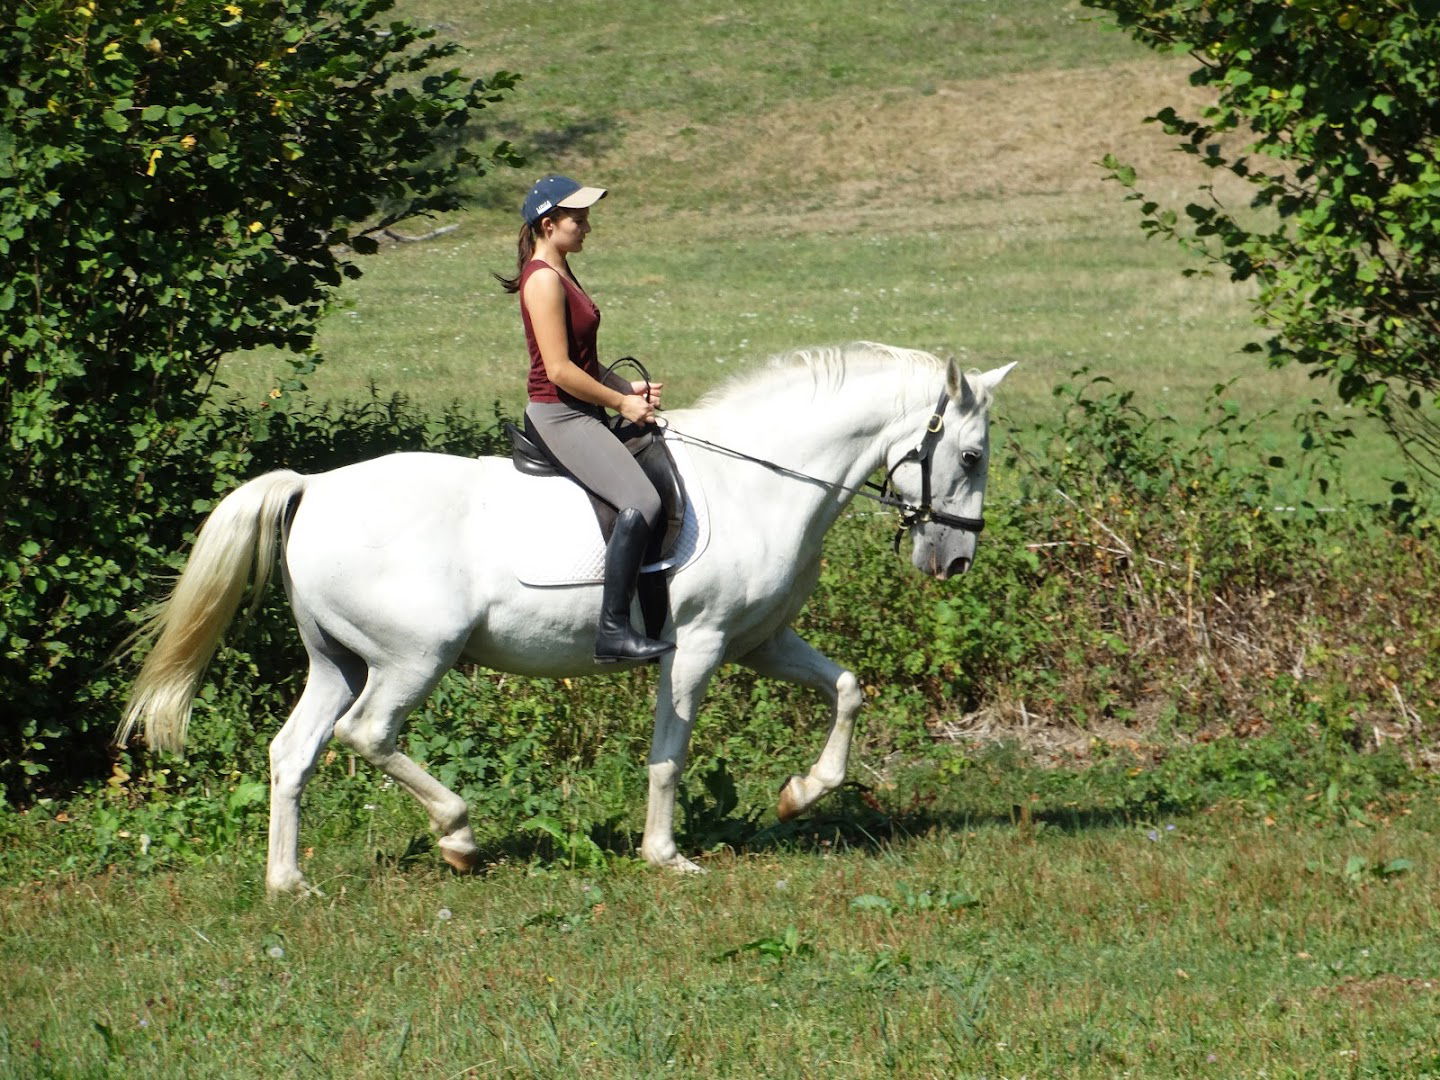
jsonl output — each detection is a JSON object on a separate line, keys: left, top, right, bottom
{"left": 0, "top": 773, "right": 1440, "bottom": 1077}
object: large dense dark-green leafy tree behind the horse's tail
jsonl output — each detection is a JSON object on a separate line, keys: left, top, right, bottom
{"left": 0, "top": 0, "right": 516, "bottom": 791}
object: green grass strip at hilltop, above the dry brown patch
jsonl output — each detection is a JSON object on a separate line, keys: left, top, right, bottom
{"left": 440, "top": 0, "right": 1139, "bottom": 137}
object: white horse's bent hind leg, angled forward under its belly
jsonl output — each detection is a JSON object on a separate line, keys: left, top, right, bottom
{"left": 336, "top": 662, "right": 480, "bottom": 871}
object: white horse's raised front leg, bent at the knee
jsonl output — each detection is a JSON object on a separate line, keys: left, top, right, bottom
{"left": 740, "top": 628, "right": 863, "bottom": 821}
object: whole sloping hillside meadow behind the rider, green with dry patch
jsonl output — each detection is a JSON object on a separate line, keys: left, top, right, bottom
{"left": 225, "top": 3, "right": 1303, "bottom": 432}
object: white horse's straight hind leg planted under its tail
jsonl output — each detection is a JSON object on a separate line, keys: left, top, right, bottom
{"left": 265, "top": 651, "right": 364, "bottom": 894}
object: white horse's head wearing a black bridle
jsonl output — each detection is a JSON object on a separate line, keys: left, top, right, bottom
{"left": 894, "top": 360, "right": 1015, "bottom": 580}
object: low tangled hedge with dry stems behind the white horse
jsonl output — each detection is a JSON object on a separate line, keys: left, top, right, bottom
{"left": 14, "top": 373, "right": 1440, "bottom": 881}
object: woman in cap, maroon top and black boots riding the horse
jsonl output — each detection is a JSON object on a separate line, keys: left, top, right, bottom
{"left": 497, "top": 174, "right": 675, "bottom": 664}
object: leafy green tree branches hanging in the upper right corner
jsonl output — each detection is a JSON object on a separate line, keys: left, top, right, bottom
{"left": 1084, "top": 0, "right": 1440, "bottom": 459}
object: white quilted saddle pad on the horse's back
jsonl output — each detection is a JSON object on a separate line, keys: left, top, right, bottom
{"left": 504, "top": 439, "right": 710, "bottom": 586}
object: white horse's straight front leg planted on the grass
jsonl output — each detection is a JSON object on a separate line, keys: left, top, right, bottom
{"left": 639, "top": 635, "right": 724, "bottom": 873}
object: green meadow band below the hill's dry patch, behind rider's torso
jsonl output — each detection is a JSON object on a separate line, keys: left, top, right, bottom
{"left": 232, "top": 204, "right": 1246, "bottom": 420}
